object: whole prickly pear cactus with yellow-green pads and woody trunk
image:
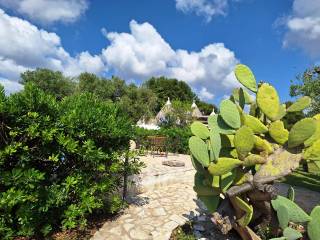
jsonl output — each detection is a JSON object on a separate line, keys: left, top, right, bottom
{"left": 189, "top": 65, "right": 320, "bottom": 239}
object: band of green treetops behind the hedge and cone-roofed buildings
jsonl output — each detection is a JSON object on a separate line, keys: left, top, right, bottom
{"left": 17, "top": 68, "right": 217, "bottom": 121}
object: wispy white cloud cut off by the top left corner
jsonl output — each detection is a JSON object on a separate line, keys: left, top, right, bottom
{"left": 0, "top": 0, "right": 89, "bottom": 24}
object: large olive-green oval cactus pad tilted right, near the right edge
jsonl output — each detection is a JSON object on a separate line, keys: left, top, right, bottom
{"left": 288, "top": 118, "right": 317, "bottom": 148}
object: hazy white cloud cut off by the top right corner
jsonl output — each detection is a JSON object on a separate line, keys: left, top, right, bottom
{"left": 283, "top": 0, "right": 320, "bottom": 57}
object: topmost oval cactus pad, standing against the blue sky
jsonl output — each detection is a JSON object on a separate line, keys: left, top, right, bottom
{"left": 234, "top": 64, "right": 257, "bottom": 92}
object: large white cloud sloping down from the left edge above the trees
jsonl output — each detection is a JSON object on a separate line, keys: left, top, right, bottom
{"left": 0, "top": 9, "right": 104, "bottom": 80}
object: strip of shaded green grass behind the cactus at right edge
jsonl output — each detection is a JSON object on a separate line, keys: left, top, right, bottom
{"left": 282, "top": 168, "right": 320, "bottom": 192}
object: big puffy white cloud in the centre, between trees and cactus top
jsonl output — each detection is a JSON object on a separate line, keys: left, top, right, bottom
{"left": 102, "top": 21, "right": 238, "bottom": 94}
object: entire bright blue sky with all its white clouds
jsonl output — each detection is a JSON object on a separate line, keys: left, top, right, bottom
{"left": 0, "top": 0, "right": 320, "bottom": 103}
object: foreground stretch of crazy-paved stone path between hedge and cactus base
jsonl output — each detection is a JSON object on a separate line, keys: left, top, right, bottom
{"left": 92, "top": 182, "right": 200, "bottom": 240}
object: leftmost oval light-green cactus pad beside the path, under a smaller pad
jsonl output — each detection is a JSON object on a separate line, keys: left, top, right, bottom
{"left": 189, "top": 136, "right": 210, "bottom": 167}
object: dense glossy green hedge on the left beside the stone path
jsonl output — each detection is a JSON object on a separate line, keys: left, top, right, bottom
{"left": 0, "top": 84, "right": 139, "bottom": 239}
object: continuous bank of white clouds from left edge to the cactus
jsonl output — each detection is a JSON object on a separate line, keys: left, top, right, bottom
{"left": 0, "top": 5, "right": 238, "bottom": 99}
